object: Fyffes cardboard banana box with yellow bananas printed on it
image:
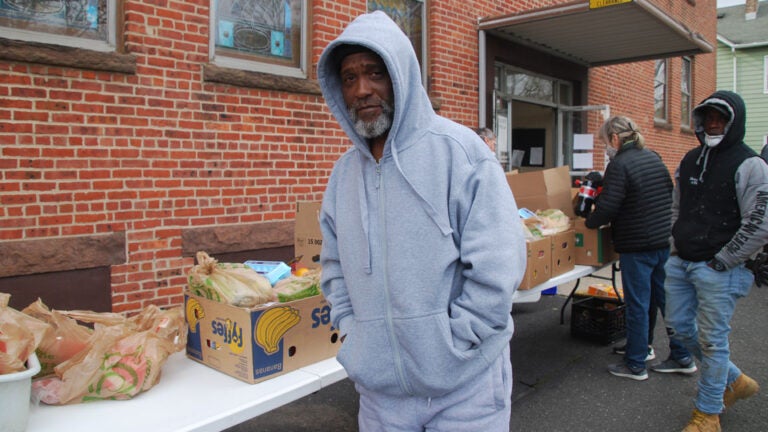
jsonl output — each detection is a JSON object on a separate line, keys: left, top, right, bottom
{"left": 184, "top": 292, "right": 341, "bottom": 384}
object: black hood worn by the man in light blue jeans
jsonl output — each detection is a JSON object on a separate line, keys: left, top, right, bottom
{"left": 693, "top": 90, "right": 747, "bottom": 148}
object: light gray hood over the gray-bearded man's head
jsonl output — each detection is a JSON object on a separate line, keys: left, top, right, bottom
{"left": 317, "top": 11, "right": 437, "bottom": 159}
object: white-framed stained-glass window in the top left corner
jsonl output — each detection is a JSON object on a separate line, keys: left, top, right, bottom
{"left": 0, "top": 0, "right": 119, "bottom": 52}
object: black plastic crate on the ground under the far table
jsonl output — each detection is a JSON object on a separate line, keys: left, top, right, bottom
{"left": 571, "top": 297, "right": 627, "bottom": 344}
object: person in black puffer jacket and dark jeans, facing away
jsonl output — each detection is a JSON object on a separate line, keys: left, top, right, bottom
{"left": 585, "top": 116, "right": 696, "bottom": 380}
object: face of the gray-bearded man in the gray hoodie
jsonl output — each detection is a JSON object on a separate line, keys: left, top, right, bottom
{"left": 340, "top": 52, "right": 395, "bottom": 138}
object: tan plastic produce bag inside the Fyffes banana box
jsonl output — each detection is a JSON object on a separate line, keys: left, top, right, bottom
{"left": 188, "top": 251, "right": 277, "bottom": 308}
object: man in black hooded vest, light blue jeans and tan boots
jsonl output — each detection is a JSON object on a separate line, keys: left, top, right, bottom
{"left": 665, "top": 91, "right": 768, "bottom": 431}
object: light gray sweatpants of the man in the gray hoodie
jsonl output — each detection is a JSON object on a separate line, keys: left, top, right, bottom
{"left": 355, "top": 345, "right": 512, "bottom": 432}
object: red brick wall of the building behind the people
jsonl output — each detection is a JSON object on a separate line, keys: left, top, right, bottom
{"left": 0, "top": 0, "right": 715, "bottom": 312}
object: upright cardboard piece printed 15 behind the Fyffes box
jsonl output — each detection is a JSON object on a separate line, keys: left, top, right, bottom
{"left": 293, "top": 201, "right": 323, "bottom": 268}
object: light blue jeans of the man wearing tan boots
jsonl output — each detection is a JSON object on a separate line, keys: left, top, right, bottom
{"left": 665, "top": 256, "right": 754, "bottom": 414}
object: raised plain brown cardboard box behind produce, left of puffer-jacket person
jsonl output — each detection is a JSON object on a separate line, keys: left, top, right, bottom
{"left": 507, "top": 166, "right": 575, "bottom": 218}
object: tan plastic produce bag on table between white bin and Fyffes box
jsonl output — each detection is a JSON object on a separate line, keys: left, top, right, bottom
{"left": 32, "top": 305, "right": 187, "bottom": 405}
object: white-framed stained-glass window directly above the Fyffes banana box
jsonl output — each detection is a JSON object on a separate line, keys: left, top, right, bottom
{"left": 210, "top": 0, "right": 309, "bottom": 79}
